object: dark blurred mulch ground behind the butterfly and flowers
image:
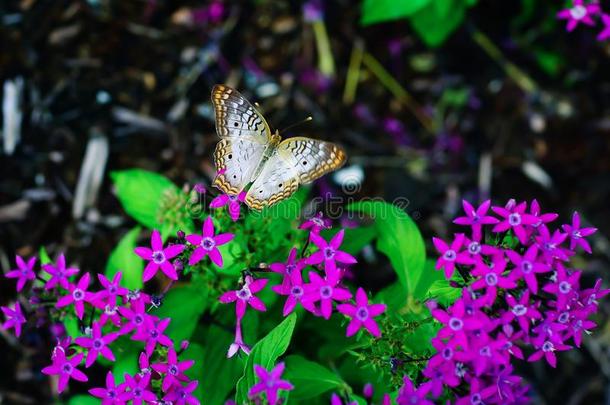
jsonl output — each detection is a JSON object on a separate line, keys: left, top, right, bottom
{"left": 0, "top": 0, "right": 610, "bottom": 404}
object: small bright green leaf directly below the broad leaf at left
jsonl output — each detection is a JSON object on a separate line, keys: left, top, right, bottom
{"left": 106, "top": 226, "right": 144, "bottom": 290}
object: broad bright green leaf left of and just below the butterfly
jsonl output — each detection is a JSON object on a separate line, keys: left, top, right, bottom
{"left": 110, "top": 169, "right": 180, "bottom": 229}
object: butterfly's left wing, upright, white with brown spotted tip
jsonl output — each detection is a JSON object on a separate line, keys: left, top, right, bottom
{"left": 212, "top": 85, "right": 271, "bottom": 195}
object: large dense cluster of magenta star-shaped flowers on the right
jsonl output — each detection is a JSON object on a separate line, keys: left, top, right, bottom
{"left": 414, "top": 200, "right": 610, "bottom": 404}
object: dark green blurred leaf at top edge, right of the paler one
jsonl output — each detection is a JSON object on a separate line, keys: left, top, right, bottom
{"left": 409, "top": 0, "right": 466, "bottom": 47}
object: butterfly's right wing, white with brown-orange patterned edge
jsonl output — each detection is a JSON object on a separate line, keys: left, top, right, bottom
{"left": 246, "top": 137, "right": 346, "bottom": 210}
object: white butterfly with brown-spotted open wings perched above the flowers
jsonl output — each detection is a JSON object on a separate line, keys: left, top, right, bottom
{"left": 212, "top": 84, "right": 347, "bottom": 210}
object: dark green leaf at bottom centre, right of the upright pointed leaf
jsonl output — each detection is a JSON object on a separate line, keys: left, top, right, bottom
{"left": 284, "top": 355, "right": 345, "bottom": 400}
